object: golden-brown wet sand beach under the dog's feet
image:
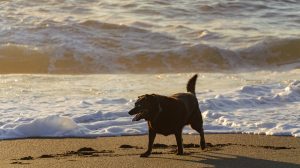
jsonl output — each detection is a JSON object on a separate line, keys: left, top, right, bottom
{"left": 0, "top": 134, "right": 300, "bottom": 168}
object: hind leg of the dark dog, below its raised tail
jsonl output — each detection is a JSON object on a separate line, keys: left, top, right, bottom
{"left": 190, "top": 108, "right": 205, "bottom": 150}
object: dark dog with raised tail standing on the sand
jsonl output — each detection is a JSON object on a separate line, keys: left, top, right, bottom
{"left": 129, "top": 75, "right": 205, "bottom": 157}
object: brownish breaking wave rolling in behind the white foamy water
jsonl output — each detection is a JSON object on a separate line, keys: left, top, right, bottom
{"left": 0, "top": 20, "right": 300, "bottom": 74}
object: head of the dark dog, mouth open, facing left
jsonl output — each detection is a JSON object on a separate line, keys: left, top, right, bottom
{"left": 128, "top": 94, "right": 160, "bottom": 121}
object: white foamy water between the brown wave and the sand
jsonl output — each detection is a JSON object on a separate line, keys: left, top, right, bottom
{"left": 0, "top": 70, "right": 300, "bottom": 139}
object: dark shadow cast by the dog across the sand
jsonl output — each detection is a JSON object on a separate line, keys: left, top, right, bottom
{"left": 150, "top": 152, "right": 299, "bottom": 168}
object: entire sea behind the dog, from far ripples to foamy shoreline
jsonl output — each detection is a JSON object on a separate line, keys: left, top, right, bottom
{"left": 0, "top": 0, "right": 300, "bottom": 139}
